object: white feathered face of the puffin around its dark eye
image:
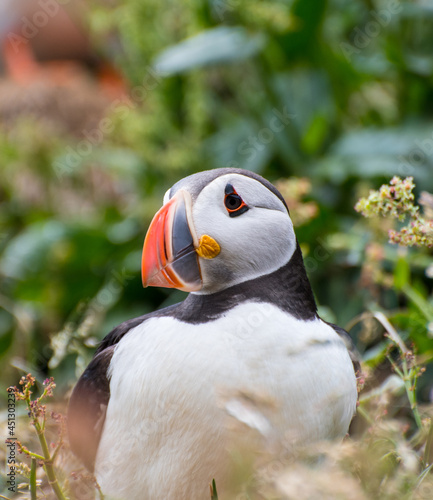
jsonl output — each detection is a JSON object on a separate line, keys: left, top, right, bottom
{"left": 192, "top": 174, "right": 296, "bottom": 293}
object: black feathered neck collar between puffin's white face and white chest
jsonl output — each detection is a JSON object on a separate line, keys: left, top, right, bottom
{"left": 176, "top": 244, "right": 317, "bottom": 323}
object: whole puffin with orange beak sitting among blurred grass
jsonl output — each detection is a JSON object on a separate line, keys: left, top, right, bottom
{"left": 68, "top": 168, "right": 359, "bottom": 500}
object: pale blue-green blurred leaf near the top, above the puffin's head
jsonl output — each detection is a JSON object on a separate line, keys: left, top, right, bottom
{"left": 154, "top": 27, "right": 265, "bottom": 76}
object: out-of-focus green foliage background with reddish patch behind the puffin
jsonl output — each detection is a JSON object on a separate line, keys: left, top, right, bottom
{"left": 0, "top": 0, "right": 433, "bottom": 422}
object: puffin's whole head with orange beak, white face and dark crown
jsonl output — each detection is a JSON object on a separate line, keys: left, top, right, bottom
{"left": 142, "top": 168, "right": 296, "bottom": 293}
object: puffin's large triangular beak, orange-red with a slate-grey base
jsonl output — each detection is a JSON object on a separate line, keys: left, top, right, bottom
{"left": 141, "top": 190, "right": 202, "bottom": 292}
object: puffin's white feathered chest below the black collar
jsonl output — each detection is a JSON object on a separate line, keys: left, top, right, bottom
{"left": 96, "top": 303, "right": 356, "bottom": 500}
